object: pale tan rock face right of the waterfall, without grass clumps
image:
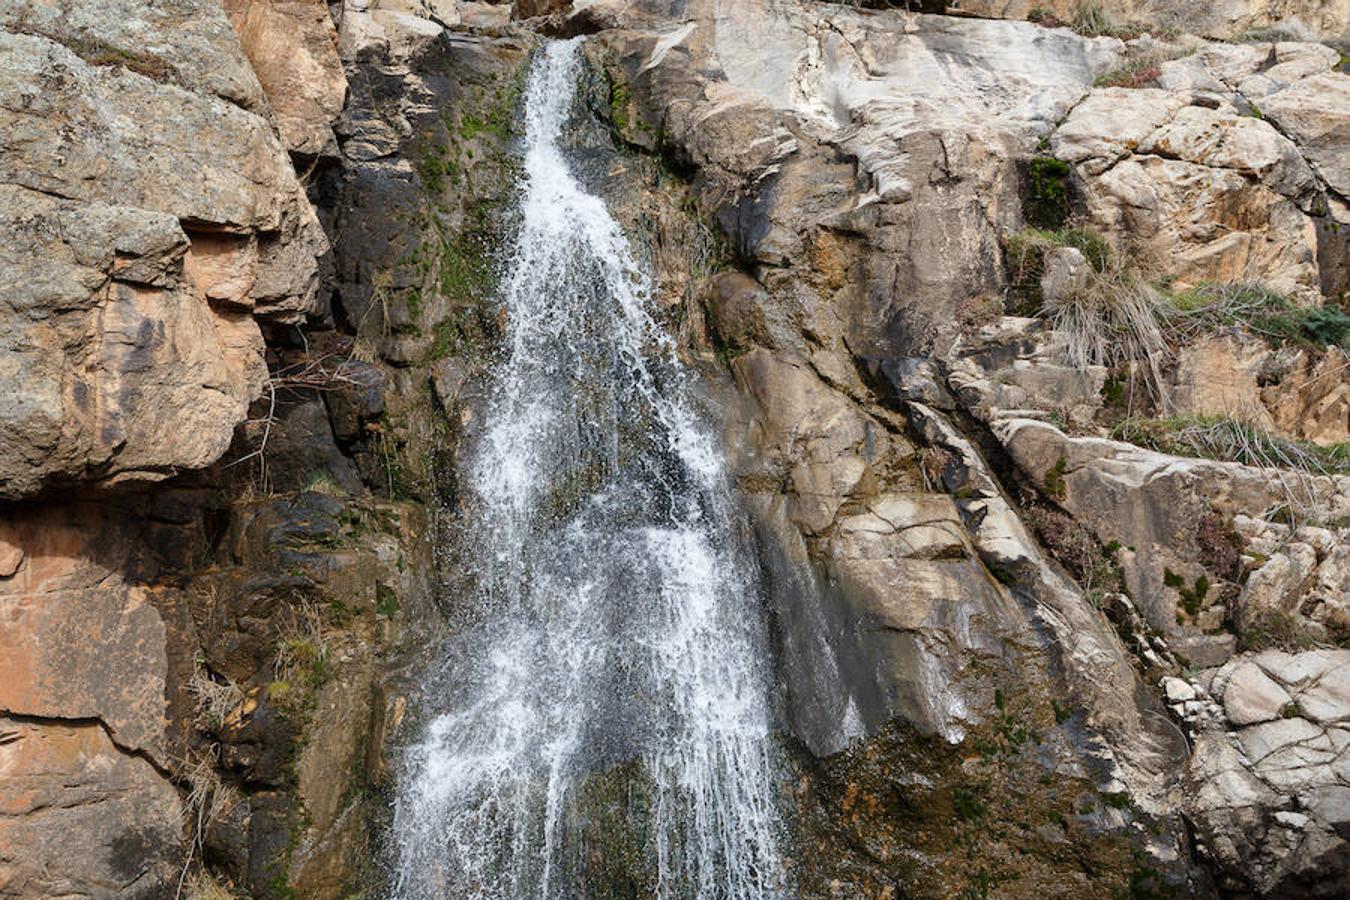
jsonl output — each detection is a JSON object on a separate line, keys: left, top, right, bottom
{"left": 585, "top": 3, "right": 1347, "bottom": 893}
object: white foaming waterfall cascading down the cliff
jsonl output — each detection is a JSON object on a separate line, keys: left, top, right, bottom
{"left": 393, "top": 40, "right": 787, "bottom": 900}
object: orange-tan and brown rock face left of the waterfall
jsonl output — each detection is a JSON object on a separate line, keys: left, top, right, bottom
{"left": 0, "top": 3, "right": 433, "bottom": 897}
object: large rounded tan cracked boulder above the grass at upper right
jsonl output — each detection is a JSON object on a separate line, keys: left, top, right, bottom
{"left": 1052, "top": 88, "right": 1320, "bottom": 294}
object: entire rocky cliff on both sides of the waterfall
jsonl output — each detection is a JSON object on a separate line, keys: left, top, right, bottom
{"left": 0, "top": 0, "right": 1350, "bottom": 897}
